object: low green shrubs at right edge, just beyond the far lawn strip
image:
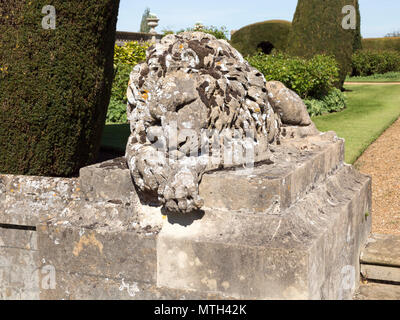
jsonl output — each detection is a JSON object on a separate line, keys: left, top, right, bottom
{"left": 352, "top": 50, "right": 400, "bottom": 76}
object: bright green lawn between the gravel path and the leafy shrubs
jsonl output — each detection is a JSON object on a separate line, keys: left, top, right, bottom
{"left": 313, "top": 85, "right": 400, "bottom": 163}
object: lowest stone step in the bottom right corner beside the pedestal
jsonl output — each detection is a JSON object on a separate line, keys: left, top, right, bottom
{"left": 355, "top": 283, "right": 400, "bottom": 300}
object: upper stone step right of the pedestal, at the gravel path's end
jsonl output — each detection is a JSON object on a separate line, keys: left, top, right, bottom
{"left": 360, "top": 234, "right": 400, "bottom": 268}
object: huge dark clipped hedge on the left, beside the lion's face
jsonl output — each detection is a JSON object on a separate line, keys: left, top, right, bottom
{"left": 0, "top": 0, "right": 119, "bottom": 176}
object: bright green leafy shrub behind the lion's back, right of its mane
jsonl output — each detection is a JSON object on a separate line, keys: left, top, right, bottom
{"left": 248, "top": 53, "right": 339, "bottom": 98}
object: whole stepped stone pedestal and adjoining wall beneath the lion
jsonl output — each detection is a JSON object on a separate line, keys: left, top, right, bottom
{"left": 0, "top": 133, "right": 371, "bottom": 299}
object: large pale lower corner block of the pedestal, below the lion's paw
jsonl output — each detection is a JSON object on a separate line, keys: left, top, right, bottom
{"left": 157, "top": 166, "right": 371, "bottom": 299}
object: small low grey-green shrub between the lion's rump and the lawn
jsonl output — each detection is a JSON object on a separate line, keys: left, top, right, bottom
{"left": 304, "top": 88, "right": 346, "bottom": 117}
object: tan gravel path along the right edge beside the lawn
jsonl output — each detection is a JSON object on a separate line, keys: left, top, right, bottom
{"left": 355, "top": 118, "right": 400, "bottom": 235}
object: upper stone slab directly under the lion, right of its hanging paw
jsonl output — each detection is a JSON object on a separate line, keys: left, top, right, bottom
{"left": 199, "top": 134, "right": 344, "bottom": 214}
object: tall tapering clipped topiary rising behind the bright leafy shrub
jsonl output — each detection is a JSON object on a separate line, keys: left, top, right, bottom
{"left": 287, "top": 0, "right": 357, "bottom": 88}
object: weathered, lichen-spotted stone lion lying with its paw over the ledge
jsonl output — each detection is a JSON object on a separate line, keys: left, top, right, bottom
{"left": 126, "top": 32, "right": 311, "bottom": 213}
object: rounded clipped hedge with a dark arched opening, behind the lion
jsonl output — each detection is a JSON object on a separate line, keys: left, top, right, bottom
{"left": 231, "top": 20, "right": 292, "bottom": 56}
